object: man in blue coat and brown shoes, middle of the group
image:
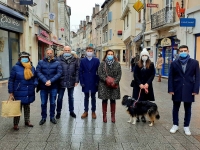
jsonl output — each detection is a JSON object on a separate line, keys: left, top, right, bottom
{"left": 79, "top": 47, "right": 100, "bottom": 119}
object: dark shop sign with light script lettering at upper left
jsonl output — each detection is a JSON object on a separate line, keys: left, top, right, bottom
{"left": 0, "top": 13, "right": 23, "bottom": 33}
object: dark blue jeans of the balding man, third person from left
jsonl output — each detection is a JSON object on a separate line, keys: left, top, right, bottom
{"left": 56, "top": 87, "right": 74, "bottom": 113}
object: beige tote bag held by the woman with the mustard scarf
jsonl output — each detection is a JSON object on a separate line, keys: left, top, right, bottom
{"left": 1, "top": 97, "right": 21, "bottom": 118}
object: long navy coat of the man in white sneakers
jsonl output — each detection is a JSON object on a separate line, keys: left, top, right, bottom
{"left": 168, "top": 58, "right": 199, "bottom": 102}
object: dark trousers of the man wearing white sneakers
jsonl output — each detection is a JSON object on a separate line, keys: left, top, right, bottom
{"left": 172, "top": 102, "right": 192, "bottom": 127}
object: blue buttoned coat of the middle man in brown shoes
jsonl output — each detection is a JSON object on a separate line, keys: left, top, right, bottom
{"left": 79, "top": 57, "right": 100, "bottom": 93}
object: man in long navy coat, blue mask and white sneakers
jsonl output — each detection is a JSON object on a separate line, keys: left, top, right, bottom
{"left": 168, "top": 45, "right": 199, "bottom": 135}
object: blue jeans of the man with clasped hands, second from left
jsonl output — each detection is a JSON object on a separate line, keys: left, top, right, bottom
{"left": 40, "top": 89, "right": 57, "bottom": 119}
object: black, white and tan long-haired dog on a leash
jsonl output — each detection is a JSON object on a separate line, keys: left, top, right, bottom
{"left": 122, "top": 95, "right": 160, "bottom": 126}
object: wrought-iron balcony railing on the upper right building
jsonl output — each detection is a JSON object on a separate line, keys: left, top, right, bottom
{"left": 151, "top": 7, "right": 175, "bottom": 29}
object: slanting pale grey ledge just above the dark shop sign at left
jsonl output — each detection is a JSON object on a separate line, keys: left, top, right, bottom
{"left": 0, "top": 4, "right": 26, "bottom": 20}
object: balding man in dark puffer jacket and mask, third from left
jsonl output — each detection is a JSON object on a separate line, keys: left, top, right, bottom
{"left": 56, "top": 46, "right": 79, "bottom": 119}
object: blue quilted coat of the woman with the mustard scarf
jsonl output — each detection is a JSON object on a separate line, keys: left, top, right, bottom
{"left": 8, "top": 62, "right": 38, "bottom": 104}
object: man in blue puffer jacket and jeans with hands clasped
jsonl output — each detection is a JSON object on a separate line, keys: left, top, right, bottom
{"left": 36, "top": 48, "right": 62, "bottom": 125}
